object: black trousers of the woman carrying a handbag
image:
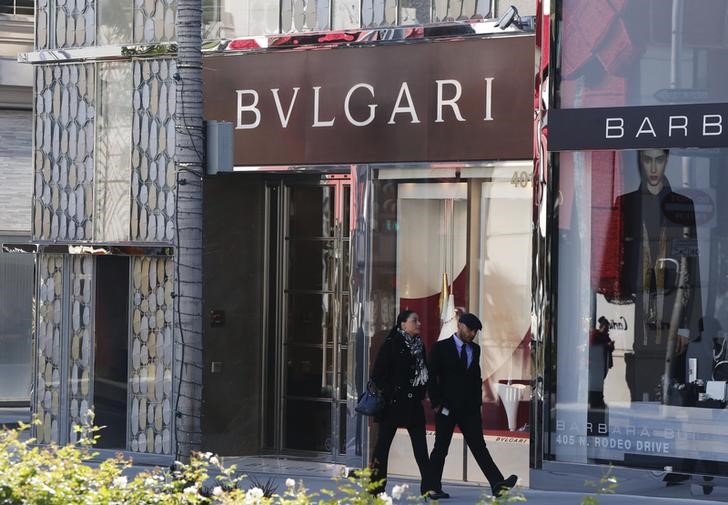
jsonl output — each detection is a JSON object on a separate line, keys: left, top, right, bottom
{"left": 369, "top": 404, "right": 429, "bottom": 494}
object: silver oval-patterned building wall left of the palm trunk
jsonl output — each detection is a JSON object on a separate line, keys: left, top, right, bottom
{"left": 25, "top": 0, "right": 179, "bottom": 455}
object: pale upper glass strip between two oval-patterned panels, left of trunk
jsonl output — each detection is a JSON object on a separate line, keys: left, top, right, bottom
{"left": 95, "top": 63, "right": 132, "bottom": 242}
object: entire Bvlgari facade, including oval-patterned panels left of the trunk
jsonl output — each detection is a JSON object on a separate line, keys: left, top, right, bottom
{"left": 11, "top": 0, "right": 533, "bottom": 480}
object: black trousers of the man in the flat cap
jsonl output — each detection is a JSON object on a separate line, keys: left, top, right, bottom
{"left": 429, "top": 410, "right": 503, "bottom": 491}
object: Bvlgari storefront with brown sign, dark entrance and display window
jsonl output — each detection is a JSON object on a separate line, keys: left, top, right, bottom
{"left": 202, "top": 29, "right": 533, "bottom": 480}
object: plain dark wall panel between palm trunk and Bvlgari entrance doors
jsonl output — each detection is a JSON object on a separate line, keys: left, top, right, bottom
{"left": 202, "top": 174, "right": 265, "bottom": 455}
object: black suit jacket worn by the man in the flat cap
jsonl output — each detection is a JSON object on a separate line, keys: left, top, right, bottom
{"left": 428, "top": 337, "right": 483, "bottom": 413}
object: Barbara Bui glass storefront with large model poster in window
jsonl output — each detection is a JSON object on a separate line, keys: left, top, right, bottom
{"left": 531, "top": 0, "right": 728, "bottom": 496}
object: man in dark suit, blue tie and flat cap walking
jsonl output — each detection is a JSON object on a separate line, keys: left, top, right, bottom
{"left": 427, "top": 312, "right": 518, "bottom": 500}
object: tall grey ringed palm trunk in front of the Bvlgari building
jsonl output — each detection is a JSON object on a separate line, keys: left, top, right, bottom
{"left": 175, "top": 0, "right": 205, "bottom": 460}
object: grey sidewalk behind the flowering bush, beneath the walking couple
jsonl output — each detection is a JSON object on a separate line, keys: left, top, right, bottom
{"left": 218, "top": 457, "right": 728, "bottom": 505}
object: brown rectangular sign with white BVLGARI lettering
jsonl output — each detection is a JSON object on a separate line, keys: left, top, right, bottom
{"left": 204, "top": 36, "right": 533, "bottom": 166}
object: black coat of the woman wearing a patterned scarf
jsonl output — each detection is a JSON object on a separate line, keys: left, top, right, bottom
{"left": 372, "top": 334, "right": 427, "bottom": 426}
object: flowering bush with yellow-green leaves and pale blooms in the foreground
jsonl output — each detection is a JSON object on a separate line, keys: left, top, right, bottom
{"left": 0, "top": 425, "right": 524, "bottom": 505}
